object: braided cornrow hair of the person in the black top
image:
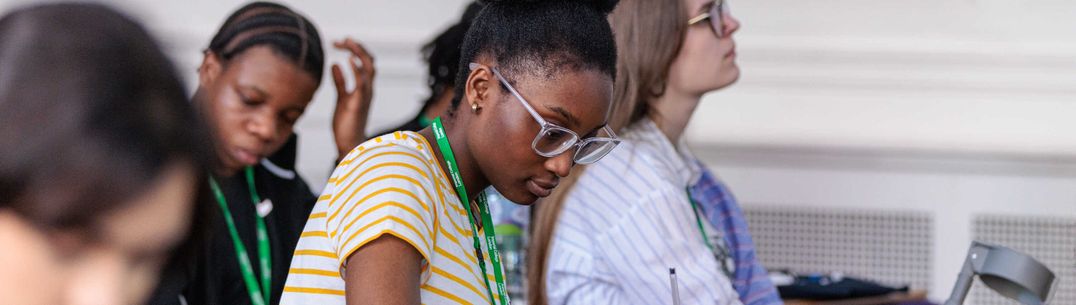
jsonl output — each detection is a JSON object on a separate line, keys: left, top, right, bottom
{"left": 208, "top": 1, "right": 325, "bottom": 85}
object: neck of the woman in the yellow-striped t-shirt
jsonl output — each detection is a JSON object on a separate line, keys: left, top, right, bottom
{"left": 419, "top": 112, "right": 490, "bottom": 208}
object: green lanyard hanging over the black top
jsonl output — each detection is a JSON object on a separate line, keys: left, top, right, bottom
{"left": 209, "top": 167, "right": 272, "bottom": 305}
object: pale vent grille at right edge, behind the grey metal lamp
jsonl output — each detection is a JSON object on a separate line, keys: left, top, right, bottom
{"left": 968, "top": 216, "right": 1076, "bottom": 305}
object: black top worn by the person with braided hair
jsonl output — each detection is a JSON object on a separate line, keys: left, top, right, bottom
{"left": 150, "top": 137, "right": 317, "bottom": 305}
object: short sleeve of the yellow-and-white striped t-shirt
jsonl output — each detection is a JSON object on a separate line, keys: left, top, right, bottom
{"left": 326, "top": 142, "right": 438, "bottom": 271}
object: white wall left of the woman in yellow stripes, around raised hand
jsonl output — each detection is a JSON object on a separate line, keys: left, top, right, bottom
{"left": 0, "top": 0, "right": 473, "bottom": 184}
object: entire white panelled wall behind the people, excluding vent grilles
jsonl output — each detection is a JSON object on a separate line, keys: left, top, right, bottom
{"left": 0, "top": 0, "right": 1076, "bottom": 300}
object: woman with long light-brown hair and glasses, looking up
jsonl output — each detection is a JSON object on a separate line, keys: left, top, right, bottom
{"left": 528, "top": 0, "right": 780, "bottom": 305}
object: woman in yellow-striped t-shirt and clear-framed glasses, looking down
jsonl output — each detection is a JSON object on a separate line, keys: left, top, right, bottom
{"left": 282, "top": 0, "right": 619, "bottom": 305}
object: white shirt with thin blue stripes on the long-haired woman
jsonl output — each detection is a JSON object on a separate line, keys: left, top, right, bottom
{"left": 546, "top": 120, "right": 741, "bottom": 305}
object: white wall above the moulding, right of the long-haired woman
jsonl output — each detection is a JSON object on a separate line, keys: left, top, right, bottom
{"left": 692, "top": 0, "right": 1076, "bottom": 155}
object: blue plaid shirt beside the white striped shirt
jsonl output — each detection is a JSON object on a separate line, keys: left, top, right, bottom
{"left": 691, "top": 164, "right": 784, "bottom": 305}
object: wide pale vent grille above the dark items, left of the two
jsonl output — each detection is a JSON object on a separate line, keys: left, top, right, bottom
{"left": 744, "top": 207, "right": 933, "bottom": 289}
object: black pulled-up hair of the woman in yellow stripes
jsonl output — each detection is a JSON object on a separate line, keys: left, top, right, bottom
{"left": 449, "top": 0, "right": 618, "bottom": 114}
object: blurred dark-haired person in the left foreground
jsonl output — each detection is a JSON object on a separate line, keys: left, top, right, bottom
{"left": 0, "top": 3, "right": 210, "bottom": 305}
